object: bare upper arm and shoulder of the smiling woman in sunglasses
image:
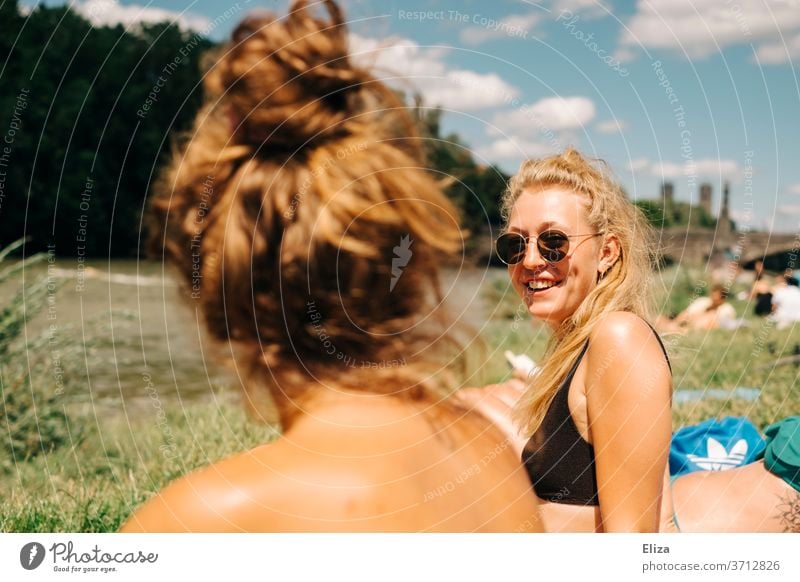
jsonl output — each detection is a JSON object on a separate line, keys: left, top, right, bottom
{"left": 585, "top": 312, "right": 672, "bottom": 532}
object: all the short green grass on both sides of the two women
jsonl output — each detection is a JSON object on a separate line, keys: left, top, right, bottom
{"left": 0, "top": 266, "right": 800, "bottom": 532}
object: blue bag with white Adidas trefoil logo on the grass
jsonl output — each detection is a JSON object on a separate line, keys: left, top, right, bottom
{"left": 669, "top": 416, "right": 765, "bottom": 476}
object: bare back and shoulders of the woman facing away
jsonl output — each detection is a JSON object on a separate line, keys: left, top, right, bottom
{"left": 123, "top": 394, "right": 542, "bottom": 532}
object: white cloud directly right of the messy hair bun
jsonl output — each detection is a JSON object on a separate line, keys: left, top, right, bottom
{"left": 350, "top": 34, "right": 519, "bottom": 110}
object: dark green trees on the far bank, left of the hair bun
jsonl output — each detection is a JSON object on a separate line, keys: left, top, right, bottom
{"left": 0, "top": 3, "right": 212, "bottom": 257}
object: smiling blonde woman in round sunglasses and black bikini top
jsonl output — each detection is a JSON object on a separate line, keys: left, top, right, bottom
{"left": 467, "top": 149, "right": 672, "bottom": 532}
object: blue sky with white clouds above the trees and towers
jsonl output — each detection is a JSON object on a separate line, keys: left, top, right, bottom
{"left": 20, "top": 0, "right": 800, "bottom": 233}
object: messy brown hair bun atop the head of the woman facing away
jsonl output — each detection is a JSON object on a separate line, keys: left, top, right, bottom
{"left": 214, "top": 0, "right": 370, "bottom": 149}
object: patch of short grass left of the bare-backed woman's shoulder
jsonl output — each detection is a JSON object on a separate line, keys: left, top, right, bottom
{"left": 0, "top": 399, "right": 275, "bottom": 532}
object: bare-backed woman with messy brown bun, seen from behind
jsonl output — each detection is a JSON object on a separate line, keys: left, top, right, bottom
{"left": 123, "top": 1, "right": 541, "bottom": 532}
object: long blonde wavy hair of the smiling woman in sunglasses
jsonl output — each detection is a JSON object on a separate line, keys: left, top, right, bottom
{"left": 510, "top": 148, "right": 656, "bottom": 434}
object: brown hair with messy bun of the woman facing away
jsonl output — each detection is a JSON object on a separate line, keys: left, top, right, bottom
{"left": 150, "top": 0, "right": 463, "bottom": 428}
